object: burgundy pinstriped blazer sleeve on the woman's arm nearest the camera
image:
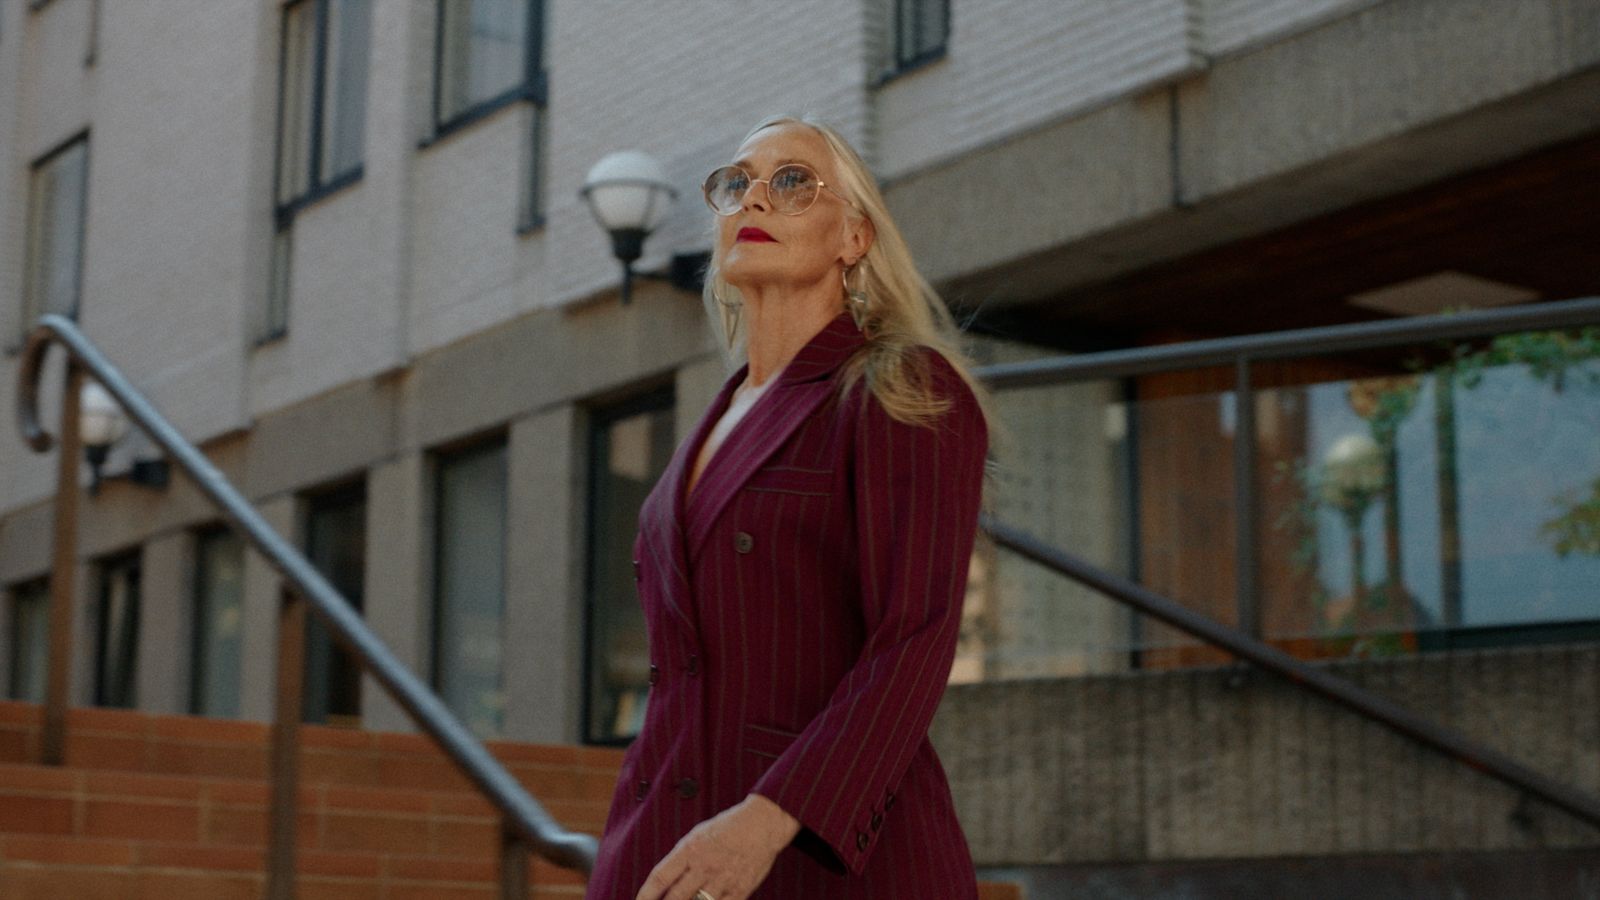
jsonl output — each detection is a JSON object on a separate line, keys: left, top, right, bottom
{"left": 754, "top": 351, "right": 989, "bottom": 874}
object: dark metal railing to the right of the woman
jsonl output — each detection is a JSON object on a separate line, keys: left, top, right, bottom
{"left": 978, "top": 298, "right": 1600, "bottom": 826}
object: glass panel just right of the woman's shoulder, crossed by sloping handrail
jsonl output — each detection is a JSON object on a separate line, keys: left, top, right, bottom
{"left": 952, "top": 347, "right": 1237, "bottom": 681}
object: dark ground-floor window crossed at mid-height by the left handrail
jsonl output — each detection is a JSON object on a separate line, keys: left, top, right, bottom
{"left": 302, "top": 484, "right": 366, "bottom": 725}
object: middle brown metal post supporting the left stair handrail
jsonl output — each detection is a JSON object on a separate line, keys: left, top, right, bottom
{"left": 267, "top": 585, "right": 306, "bottom": 900}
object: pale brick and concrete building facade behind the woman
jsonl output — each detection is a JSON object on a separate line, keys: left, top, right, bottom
{"left": 0, "top": 0, "right": 1600, "bottom": 883}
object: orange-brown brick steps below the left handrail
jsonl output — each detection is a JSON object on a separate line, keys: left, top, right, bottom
{"left": 0, "top": 701, "right": 1021, "bottom": 900}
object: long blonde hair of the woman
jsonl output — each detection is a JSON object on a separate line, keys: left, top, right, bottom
{"left": 704, "top": 115, "right": 995, "bottom": 434}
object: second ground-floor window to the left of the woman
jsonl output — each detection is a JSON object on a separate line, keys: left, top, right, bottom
{"left": 434, "top": 440, "right": 506, "bottom": 738}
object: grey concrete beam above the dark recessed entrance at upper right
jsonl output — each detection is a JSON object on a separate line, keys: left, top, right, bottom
{"left": 888, "top": 0, "right": 1600, "bottom": 304}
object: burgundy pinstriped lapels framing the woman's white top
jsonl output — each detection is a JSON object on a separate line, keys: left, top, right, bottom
{"left": 674, "top": 312, "right": 864, "bottom": 560}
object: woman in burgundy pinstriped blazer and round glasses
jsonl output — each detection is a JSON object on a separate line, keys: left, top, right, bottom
{"left": 587, "top": 119, "right": 989, "bottom": 900}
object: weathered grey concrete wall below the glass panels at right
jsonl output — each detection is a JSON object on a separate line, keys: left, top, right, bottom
{"left": 933, "top": 637, "right": 1600, "bottom": 866}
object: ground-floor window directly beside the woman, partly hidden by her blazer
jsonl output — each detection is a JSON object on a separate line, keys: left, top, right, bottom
{"left": 584, "top": 389, "right": 674, "bottom": 743}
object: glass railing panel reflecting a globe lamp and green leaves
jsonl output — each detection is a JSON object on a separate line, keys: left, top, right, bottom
{"left": 1258, "top": 333, "right": 1600, "bottom": 658}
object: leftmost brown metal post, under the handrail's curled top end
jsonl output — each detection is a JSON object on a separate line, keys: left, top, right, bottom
{"left": 40, "top": 362, "right": 83, "bottom": 765}
